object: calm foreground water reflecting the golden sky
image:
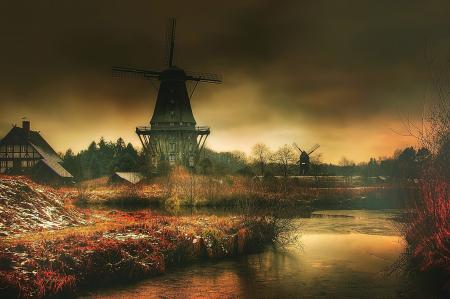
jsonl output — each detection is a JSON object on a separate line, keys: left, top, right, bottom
{"left": 81, "top": 210, "right": 432, "bottom": 298}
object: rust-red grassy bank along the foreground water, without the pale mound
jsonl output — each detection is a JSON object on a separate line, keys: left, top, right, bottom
{"left": 0, "top": 214, "right": 275, "bottom": 298}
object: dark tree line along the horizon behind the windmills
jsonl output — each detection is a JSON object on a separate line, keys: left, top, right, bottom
{"left": 62, "top": 138, "right": 438, "bottom": 180}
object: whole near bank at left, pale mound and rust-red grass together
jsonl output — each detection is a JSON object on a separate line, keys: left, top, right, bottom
{"left": 0, "top": 176, "right": 278, "bottom": 298}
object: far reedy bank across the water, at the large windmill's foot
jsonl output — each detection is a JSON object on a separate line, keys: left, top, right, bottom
{"left": 66, "top": 170, "right": 408, "bottom": 210}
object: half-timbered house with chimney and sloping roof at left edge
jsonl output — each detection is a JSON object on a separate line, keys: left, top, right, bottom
{"left": 0, "top": 120, "right": 73, "bottom": 184}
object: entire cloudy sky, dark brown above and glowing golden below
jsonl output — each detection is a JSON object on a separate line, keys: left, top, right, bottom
{"left": 0, "top": 0, "right": 450, "bottom": 162}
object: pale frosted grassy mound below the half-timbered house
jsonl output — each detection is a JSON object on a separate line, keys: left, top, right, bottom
{"left": 0, "top": 176, "right": 85, "bottom": 236}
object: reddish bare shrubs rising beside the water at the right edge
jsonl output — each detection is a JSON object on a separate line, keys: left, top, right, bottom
{"left": 402, "top": 54, "right": 450, "bottom": 286}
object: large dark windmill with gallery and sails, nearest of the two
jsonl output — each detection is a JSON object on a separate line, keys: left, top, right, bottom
{"left": 113, "top": 19, "right": 222, "bottom": 169}
